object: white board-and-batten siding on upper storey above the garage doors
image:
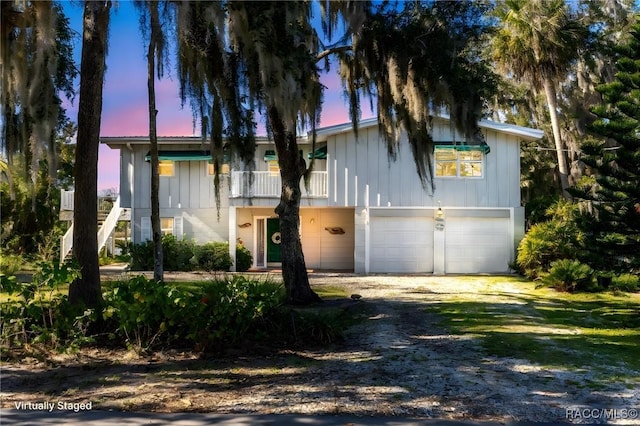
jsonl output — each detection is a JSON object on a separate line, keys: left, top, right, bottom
{"left": 326, "top": 116, "right": 521, "bottom": 207}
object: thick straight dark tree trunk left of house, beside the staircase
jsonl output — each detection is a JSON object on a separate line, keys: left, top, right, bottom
{"left": 69, "top": 0, "right": 111, "bottom": 308}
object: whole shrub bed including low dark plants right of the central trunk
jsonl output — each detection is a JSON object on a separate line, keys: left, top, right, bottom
{"left": 103, "top": 274, "right": 352, "bottom": 352}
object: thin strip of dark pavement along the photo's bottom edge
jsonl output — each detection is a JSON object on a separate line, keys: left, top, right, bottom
{"left": 0, "top": 409, "right": 523, "bottom": 426}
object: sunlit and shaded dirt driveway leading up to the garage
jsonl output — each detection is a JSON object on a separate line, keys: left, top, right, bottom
{"left": 2, "top": 274, "right": 640, "bottom": 424}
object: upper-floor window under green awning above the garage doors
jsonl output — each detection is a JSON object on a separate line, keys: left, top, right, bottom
{"left": 435, "top": 146, "right": 484, "bottom": 178}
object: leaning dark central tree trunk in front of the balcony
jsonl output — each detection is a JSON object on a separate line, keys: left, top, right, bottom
{"left": 268, "top": 106, "right": 322, "bottom": 305}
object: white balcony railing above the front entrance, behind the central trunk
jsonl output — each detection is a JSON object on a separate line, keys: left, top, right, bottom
{"left": 231, "top": 171, "right": 327, "bottom": 198}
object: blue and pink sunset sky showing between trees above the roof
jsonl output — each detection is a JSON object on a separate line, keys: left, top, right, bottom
{"left": 64, "top": 0, "right": 372, "bottom": 190}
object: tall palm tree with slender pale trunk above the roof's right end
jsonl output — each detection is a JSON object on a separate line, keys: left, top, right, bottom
{"left": 492, "top": 0, "right": 588, "bottom": 198}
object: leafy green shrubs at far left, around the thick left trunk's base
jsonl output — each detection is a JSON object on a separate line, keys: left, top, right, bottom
{"left": 0, "top": 262, "right": 95, "bottom": 349}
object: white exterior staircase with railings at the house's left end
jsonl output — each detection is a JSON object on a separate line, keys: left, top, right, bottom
{"left": 60, "top": 191, "right": 124, "bottom": 263}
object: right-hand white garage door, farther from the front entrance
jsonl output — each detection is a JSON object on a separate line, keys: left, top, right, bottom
{"left": 445, "top": 217, "right": 513, "bottom": 274}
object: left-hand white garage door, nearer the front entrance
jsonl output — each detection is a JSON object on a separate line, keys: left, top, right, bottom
{"left": 369, "top": 217, "right": 433, "bottom": 273}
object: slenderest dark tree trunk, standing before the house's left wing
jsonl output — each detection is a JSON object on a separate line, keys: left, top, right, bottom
{"left": 147, "top": 1, "right": 164, "bottom": 282}
